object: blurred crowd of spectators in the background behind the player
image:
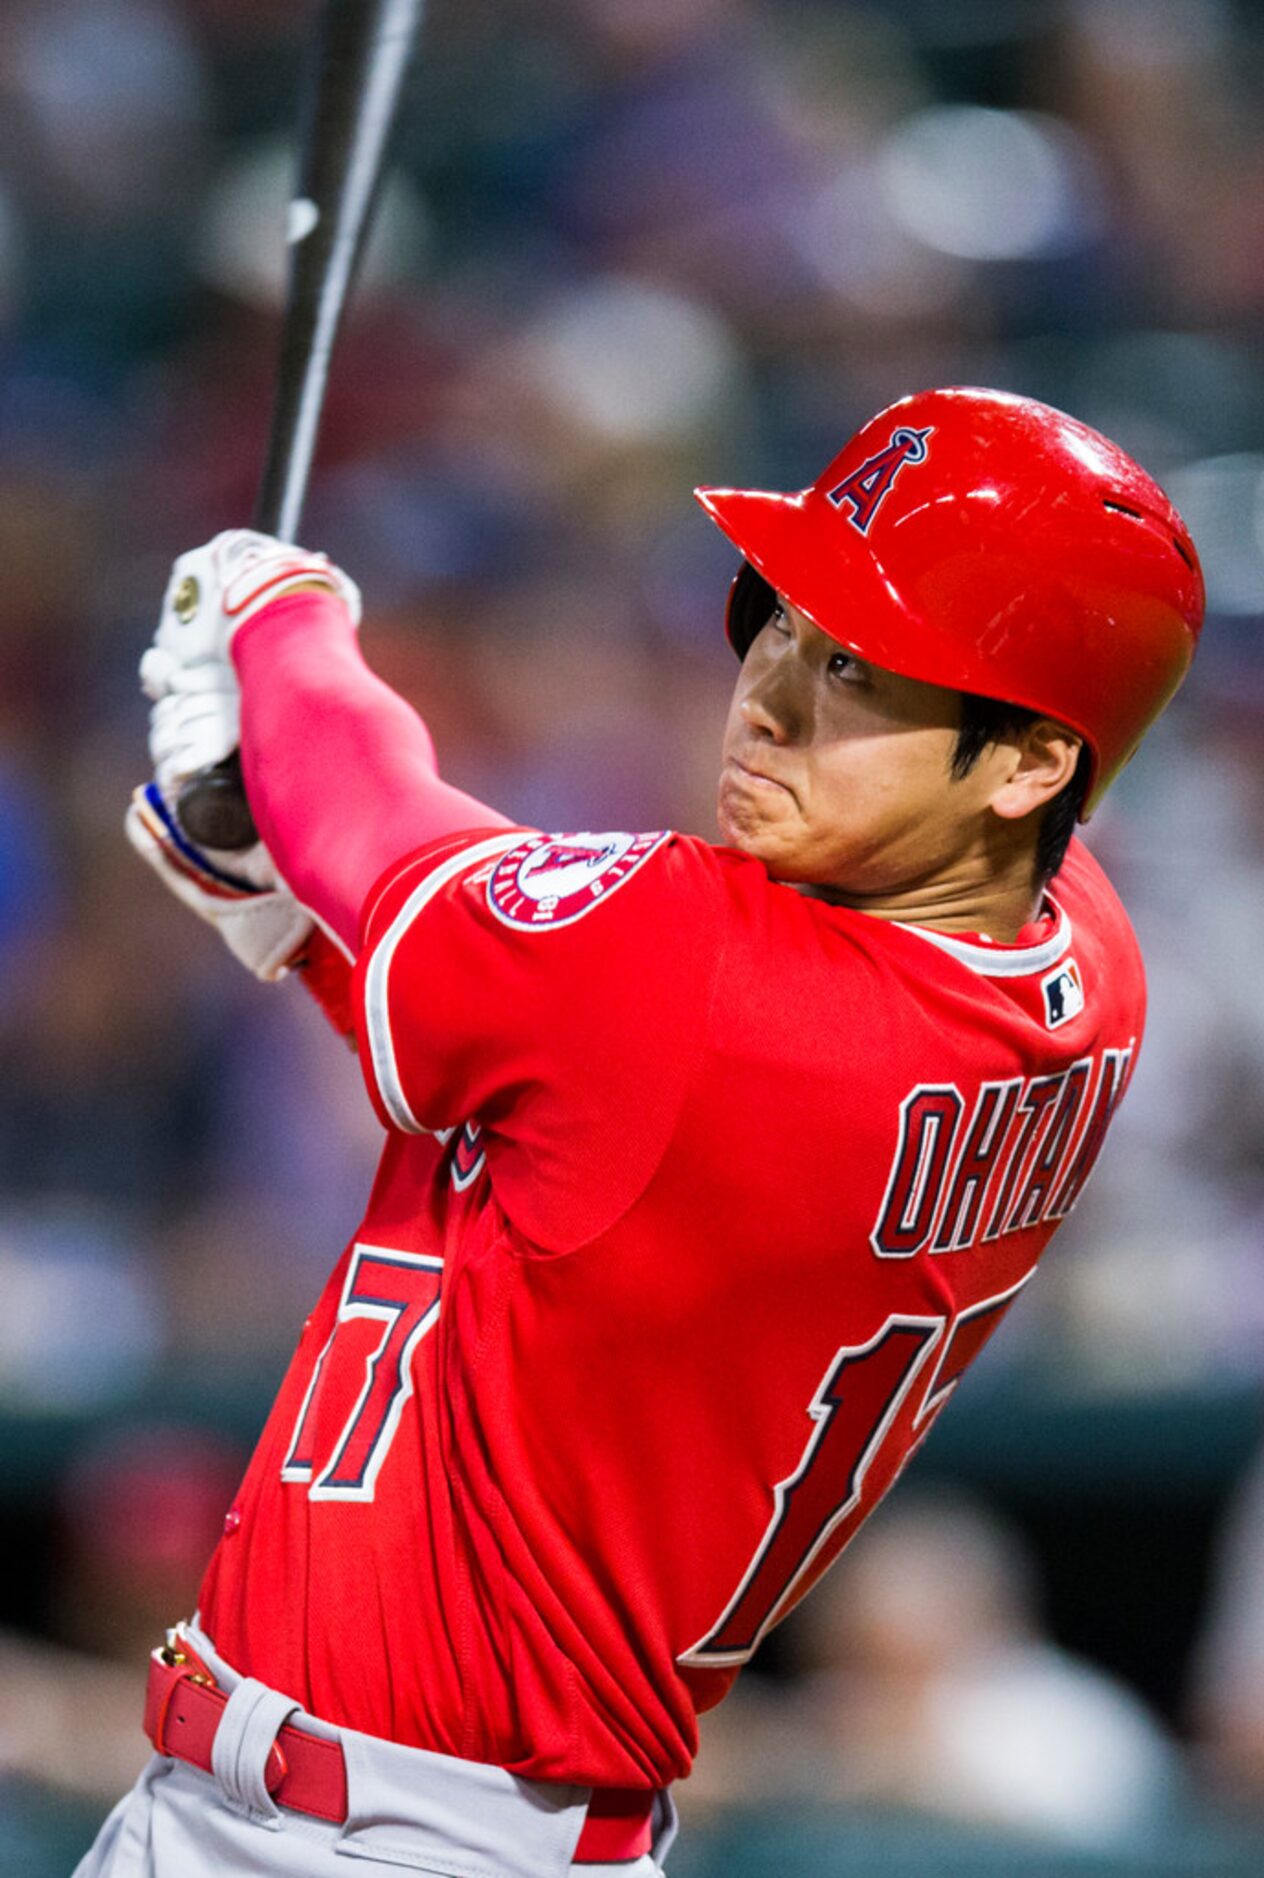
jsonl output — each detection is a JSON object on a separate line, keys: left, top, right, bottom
{"left": 0, "top": 0, "right": 1264, "bottom": 1870}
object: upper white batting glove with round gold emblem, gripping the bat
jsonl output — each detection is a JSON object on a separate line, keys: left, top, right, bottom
{"left": 141, "top": 528, "right": 361, "bottom": 706}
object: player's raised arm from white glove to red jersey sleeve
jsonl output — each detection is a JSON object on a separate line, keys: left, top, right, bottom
{"left": 134, "top": 530, "right": 721, "bottom": 1249}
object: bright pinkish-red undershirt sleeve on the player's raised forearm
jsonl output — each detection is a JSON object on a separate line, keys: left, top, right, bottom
{"left": 233, "top": 588, "right": 513, "bottom": 958}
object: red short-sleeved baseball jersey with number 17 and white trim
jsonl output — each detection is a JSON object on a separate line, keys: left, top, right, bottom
{"left": 201, "top": 830, "right": 1144, "bottom": 1786}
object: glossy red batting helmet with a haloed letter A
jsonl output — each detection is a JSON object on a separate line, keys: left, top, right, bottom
{"left": 697, "top": 387, "right": 1204, "bottom": 815}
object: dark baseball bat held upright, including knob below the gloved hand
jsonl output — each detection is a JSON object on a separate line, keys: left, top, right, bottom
{"left": 177, "top": 0, "right": 423, "bottom": 853}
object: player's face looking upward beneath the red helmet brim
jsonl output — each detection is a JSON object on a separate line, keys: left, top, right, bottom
{"left": 717, "top": 601, "right": 997, "bottom": 903}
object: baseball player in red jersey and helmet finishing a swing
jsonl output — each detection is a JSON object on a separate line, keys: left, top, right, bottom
{"left": 81, "top": 389, "right": 1202, "bottom": 1878}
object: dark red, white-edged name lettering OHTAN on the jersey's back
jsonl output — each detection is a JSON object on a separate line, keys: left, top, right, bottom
{"left": 870, "top": 1042, "right": 1134, "bottom": 1258}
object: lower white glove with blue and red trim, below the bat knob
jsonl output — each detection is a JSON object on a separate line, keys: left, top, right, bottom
{"left": 124, "top": 783, "right": 312, "bottom": 980}
